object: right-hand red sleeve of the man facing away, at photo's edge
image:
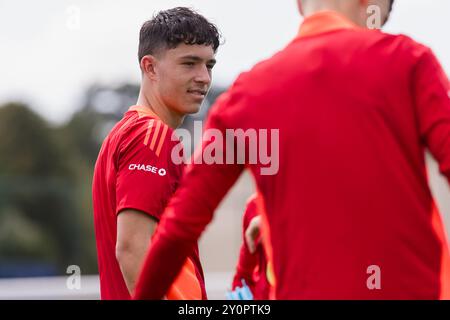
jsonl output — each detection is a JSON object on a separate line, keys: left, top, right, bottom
{"left": 413, "top": 49, "right": 450, "bottom": 182}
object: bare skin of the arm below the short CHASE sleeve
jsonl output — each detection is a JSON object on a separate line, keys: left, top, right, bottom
{"left": 116, "top": 209, "right": 157, "bottom": 295}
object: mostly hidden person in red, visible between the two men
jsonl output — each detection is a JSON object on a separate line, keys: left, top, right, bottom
{"left": 232, "top": 195, "right": 271, "bottom": 300}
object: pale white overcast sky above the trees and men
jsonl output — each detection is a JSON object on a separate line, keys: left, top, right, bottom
{"left": 0, "top": 0, "right": 450, "bottom": 123}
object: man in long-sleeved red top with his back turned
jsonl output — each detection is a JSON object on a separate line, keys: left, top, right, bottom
{"left": 135, "top": 0, "right": 450, "bottom": 299}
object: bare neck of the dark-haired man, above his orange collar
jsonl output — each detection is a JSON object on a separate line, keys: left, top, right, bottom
{"left": 136, "top": 90, "right": 184, "bottom": 129}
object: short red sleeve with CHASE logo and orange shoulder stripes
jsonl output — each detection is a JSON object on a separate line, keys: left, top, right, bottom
{"left": 116, "top": 119, "right": 182, "bottom": 220}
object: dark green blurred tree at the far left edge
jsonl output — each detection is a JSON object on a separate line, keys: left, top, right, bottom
{"left": 0, "top": 103, "right": 81, "bottom": 273}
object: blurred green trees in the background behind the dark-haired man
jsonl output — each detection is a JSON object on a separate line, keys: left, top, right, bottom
{"left": 0, "top": 84, "right": 224, "bottom": 278}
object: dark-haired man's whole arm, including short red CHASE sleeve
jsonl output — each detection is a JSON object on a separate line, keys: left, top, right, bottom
{"left": 116, "top": 117, "right": 181, "bottom": 298}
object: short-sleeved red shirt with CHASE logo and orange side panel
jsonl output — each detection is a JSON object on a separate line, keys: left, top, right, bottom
{"left": 92, "top": 106, "right": 206, "bottom": 300}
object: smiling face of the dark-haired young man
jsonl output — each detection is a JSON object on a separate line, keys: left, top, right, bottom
{"left": 154, "top": 44, "right": 216, "bottom": 115}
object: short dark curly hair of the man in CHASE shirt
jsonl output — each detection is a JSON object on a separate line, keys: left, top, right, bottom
{"left": 138, "top": 7, "right": 220, "bottom": 62}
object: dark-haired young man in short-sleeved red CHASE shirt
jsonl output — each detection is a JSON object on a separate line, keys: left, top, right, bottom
{"left": 93, "top": 7, "right": 219, "bottom": 299}
